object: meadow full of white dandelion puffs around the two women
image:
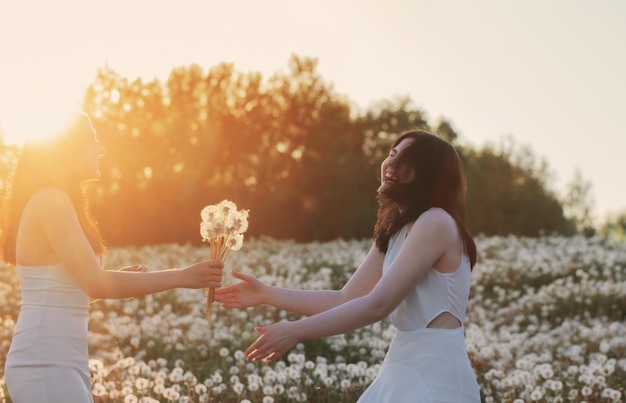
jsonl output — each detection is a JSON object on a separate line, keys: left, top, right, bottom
{"left": 0, "top": 236, "right": 626, "bottom": 403}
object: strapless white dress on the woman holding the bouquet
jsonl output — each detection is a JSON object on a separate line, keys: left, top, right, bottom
{"left": 4, "top": 265, "right": 93, "bottom": 403}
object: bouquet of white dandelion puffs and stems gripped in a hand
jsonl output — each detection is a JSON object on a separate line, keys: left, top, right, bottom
{"left": 200, "top": 200, "right": 248, "bottom": 326}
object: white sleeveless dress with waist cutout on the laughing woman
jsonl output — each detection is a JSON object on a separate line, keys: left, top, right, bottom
{"left": 358, "top": 223, "right": 480, "bottom": 403}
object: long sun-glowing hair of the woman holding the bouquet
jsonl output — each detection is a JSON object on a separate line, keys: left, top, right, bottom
{"left": 0, "top": 113, "right": 105, "bottom": 266}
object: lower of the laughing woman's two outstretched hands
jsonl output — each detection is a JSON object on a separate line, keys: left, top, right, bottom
{"left": 245, "top": 321, "right": 300, "bottom": 361}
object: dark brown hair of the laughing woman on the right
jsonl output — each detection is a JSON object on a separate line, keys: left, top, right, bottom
{"left": 374, "top": 130, "right": 477, "bottom": 267}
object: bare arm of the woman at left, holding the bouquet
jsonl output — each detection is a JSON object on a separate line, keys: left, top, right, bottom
{"left": 32, "top": 189, "right": 223, "bottom": 299}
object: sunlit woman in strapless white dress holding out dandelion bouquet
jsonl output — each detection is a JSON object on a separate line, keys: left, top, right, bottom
{"left": 0, "top": 113, "right": 223, "bottom": 403}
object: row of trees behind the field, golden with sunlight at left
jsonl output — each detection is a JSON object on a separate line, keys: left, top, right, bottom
{"left": 0, "top": 56, "right": 604, "bottom": 246}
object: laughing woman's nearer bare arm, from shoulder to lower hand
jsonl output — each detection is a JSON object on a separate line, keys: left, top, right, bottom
{"left": 246, "top": 211, "right": 459, "bottom": 360}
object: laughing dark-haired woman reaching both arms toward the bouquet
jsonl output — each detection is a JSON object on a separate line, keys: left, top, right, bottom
{"left": 216, "top": 130, "right": 480, "bottom": 403}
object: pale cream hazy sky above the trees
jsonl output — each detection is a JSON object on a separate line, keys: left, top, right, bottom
{"left": 0, "top": 0, "right": 626, "bottom": 222}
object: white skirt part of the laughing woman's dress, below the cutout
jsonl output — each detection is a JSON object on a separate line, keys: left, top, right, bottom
{"left": 358, "top": 327, "right": 480, "bottom": 403}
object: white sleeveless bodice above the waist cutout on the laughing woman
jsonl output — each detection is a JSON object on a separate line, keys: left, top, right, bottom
{"left": 383, "top": 218, "right": 471, "bottom": 331}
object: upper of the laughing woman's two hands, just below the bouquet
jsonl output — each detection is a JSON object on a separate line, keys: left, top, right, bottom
{"left": 215, "top": 270, "right": 267, "bottom": 308}
